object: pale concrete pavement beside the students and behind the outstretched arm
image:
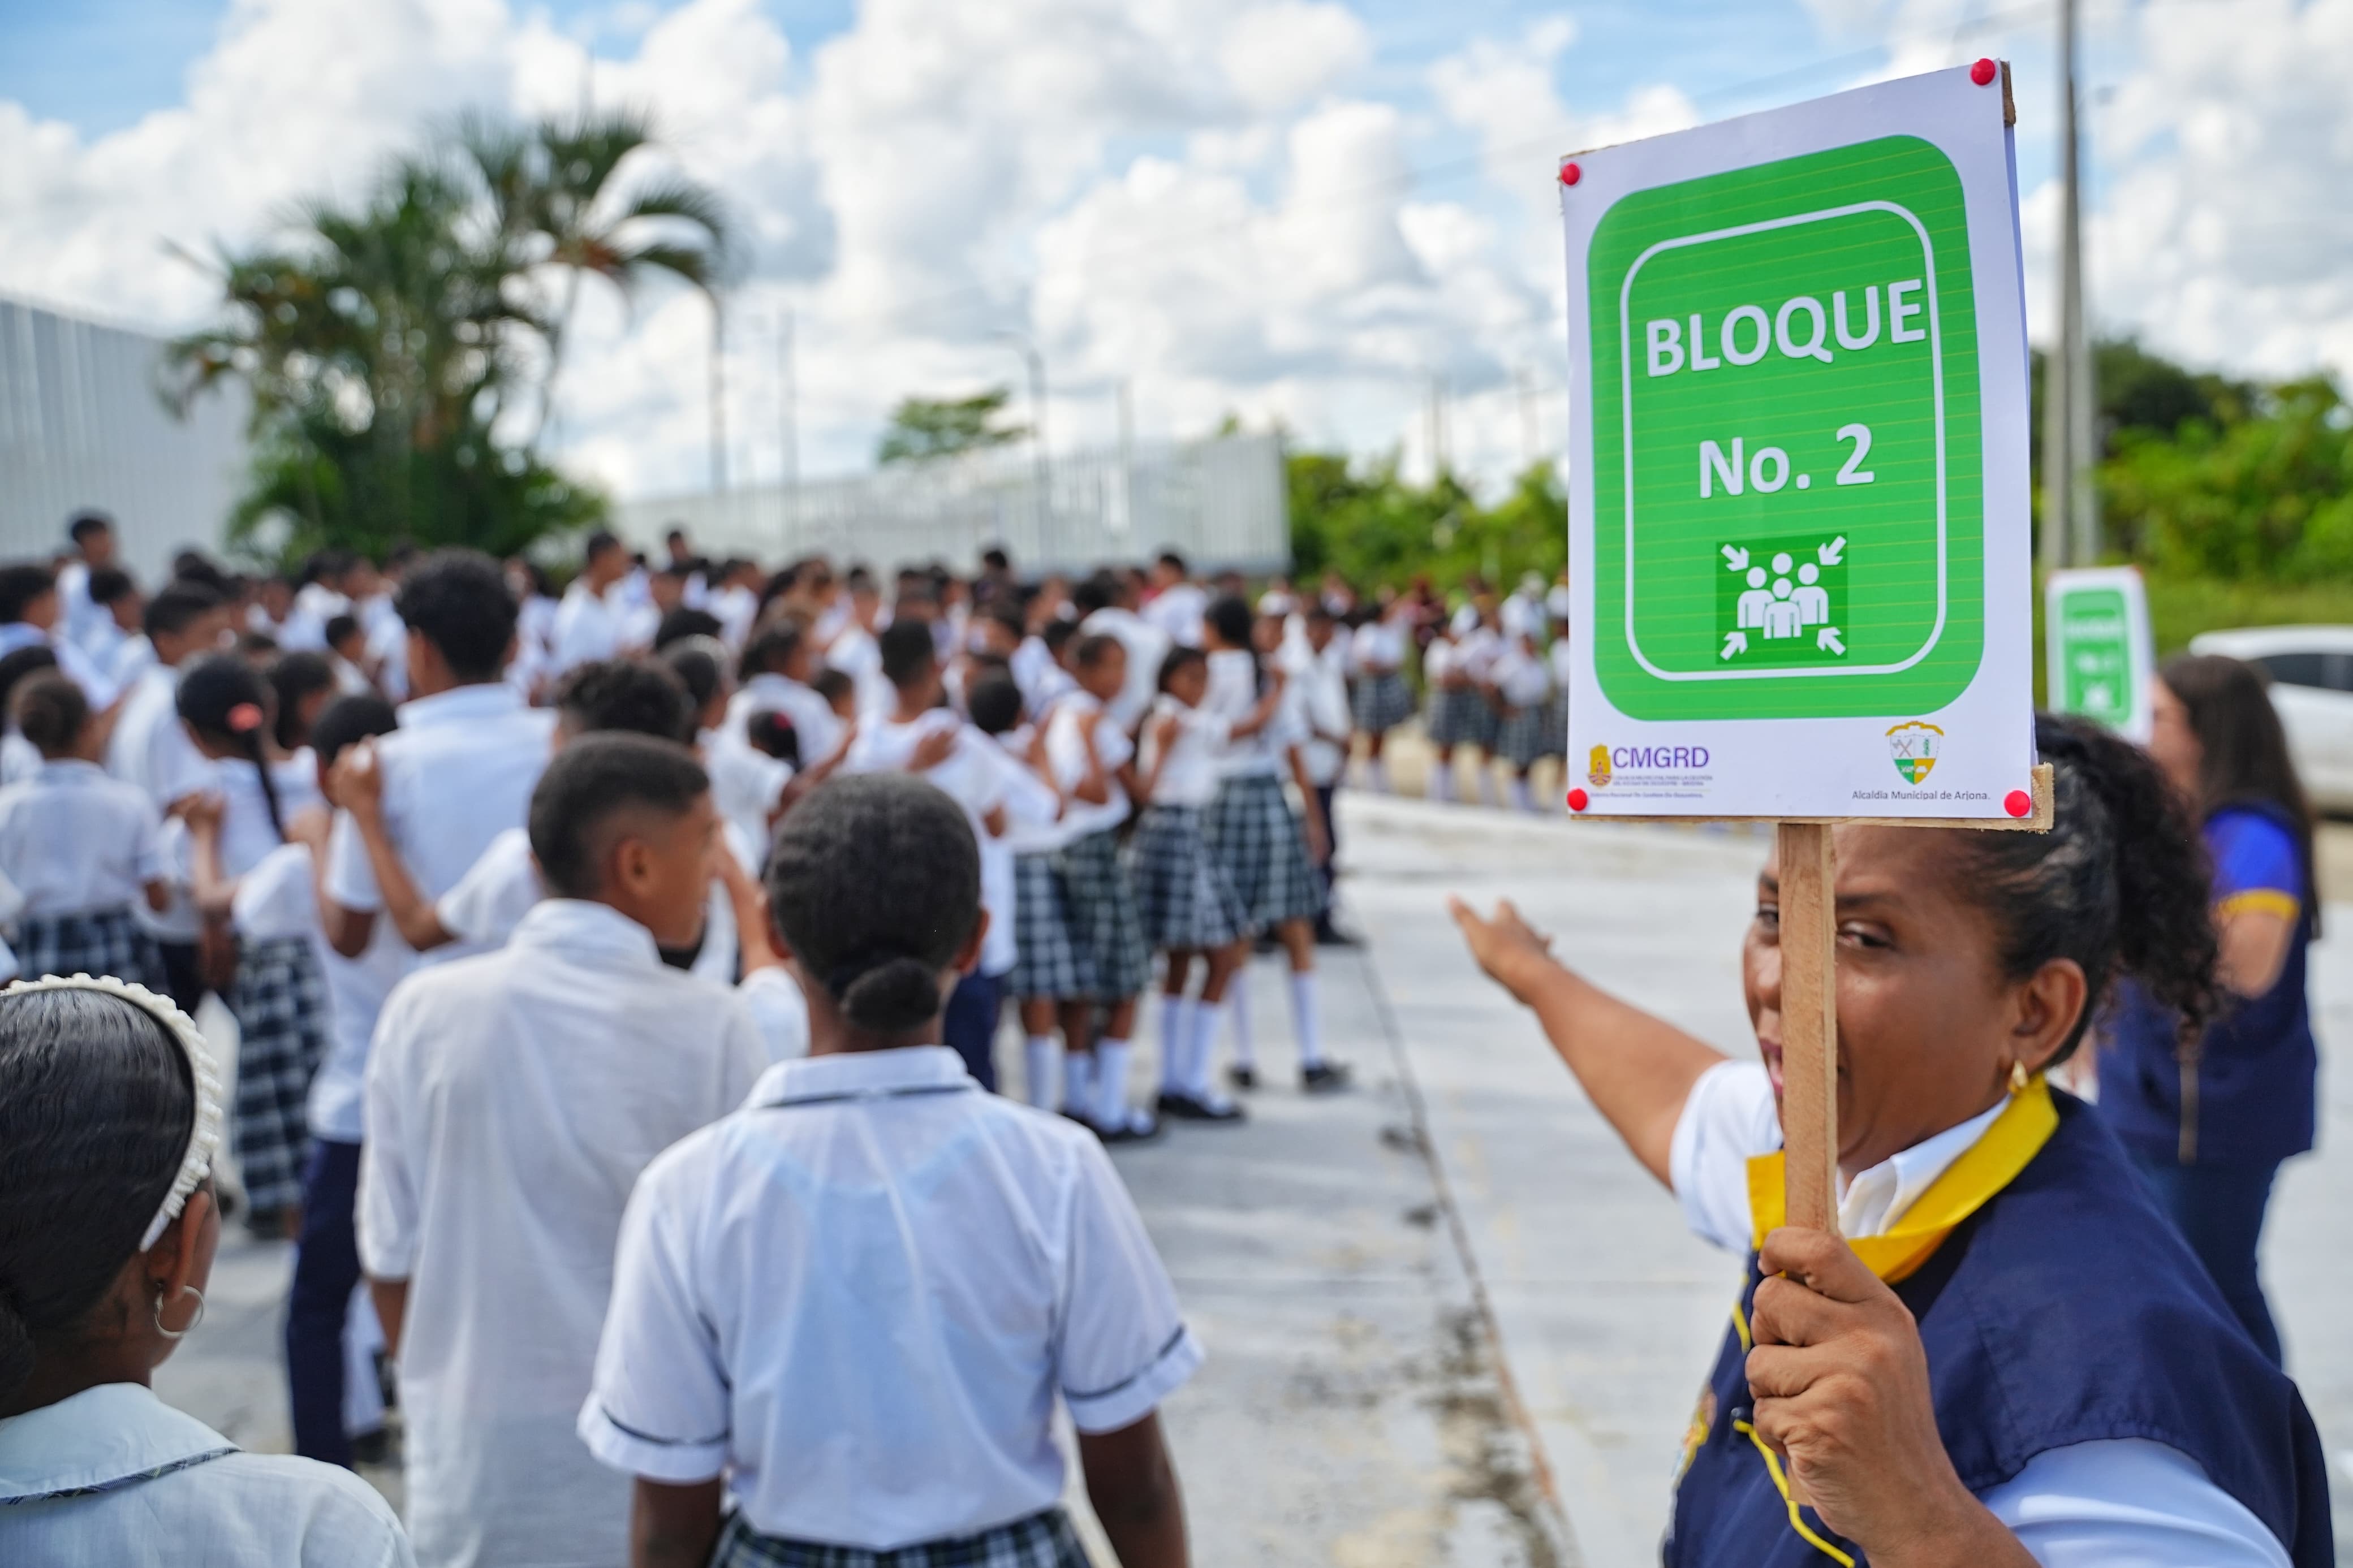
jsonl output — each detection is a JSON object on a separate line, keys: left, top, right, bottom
{"left": 158, "top": 797, "right": 2353, "bottom": 1568}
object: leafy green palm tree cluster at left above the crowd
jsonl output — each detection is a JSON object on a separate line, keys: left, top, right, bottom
{"left": 162, "top": 115, "right": 727, "bottom": 557}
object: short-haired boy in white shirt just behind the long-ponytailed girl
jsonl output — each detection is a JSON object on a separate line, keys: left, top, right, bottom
{"left": 106, "top": 583, "right": 231, "bottom": 1011}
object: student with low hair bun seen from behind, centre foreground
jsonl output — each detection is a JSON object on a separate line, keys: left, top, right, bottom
{"left": 579, "top": 774, "right": 1200, "bottom": 1568}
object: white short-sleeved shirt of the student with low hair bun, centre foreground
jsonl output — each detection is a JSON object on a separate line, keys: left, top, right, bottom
{"left": 579, "top": 1046, "right": 1203, "bottom": 1552}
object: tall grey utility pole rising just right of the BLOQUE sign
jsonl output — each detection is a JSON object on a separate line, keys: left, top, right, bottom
{"left": 2042, "top": 0, "right": 2099, "bottom": 569}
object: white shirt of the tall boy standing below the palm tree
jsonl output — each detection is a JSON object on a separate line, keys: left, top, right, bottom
{"left": 327, "top": 682, "right": 555, "bottom": 961}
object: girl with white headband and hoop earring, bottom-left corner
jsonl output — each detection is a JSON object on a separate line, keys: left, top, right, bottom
{"left": 0, "top": 980, "right": 414, "bottom": 1568}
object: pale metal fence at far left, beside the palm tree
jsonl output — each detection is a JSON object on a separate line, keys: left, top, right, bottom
{"left": 0, "top": 299, "right": 247, "bottom": 585}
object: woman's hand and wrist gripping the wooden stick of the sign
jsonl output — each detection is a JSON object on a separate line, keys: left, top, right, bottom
{"left": 1748, "top": 1227, "right": 2033, "bottom": 1568}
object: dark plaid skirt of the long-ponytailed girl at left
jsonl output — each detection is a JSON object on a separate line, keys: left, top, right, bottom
{"left": 229, "top": 936, "right": 327, "bottom": 1211}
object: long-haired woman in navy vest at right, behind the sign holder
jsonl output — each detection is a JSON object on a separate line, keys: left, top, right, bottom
{"left": 2099, "top": 654, "right": 2320, "bottom": 1361}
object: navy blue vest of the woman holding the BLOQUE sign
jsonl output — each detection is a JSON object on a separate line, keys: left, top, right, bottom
{"left": 1661, "top": 1091, "right": 2334, "bottom": 1568}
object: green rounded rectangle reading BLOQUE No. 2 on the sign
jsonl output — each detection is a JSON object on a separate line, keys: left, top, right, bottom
{"left": 1588, "top": 136, "right": 1986, "bottom": 719}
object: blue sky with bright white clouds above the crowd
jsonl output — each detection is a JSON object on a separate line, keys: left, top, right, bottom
{"left": 0, "top": 0, "right": 2353, "bottom": 494}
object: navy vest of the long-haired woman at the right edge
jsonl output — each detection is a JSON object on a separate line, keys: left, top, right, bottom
{"left": 2099, "top": 802, "right": 2320, "bottom": 1166}
